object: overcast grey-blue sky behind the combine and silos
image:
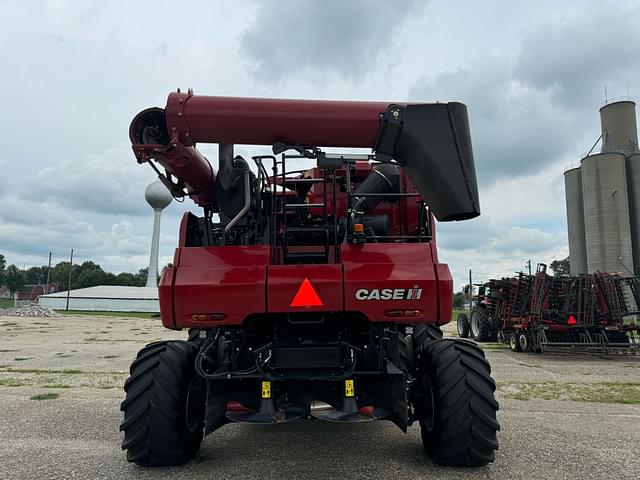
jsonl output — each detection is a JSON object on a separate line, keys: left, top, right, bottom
{"left": 0, "top": 0, "right": 640, "bottom": 287}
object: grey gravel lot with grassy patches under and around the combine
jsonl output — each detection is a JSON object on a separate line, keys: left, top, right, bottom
{"left": 0, "top": 316, "right": 640, "bottom": 480}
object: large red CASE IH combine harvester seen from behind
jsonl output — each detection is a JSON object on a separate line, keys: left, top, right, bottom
{"left": 121, "top": 91, "right": 499, "bottom": 465}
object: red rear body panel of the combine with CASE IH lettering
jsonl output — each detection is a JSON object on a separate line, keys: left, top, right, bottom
{"left": 159, "top": 243, "right": 453, "bottom": 329}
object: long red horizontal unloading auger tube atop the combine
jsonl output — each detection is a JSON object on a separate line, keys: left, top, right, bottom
{"left": 166, "top": 93, "right": 398, "bottom": 147}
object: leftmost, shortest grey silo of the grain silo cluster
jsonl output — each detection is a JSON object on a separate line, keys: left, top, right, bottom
{"left": 564, "top": 167, "right": 587, "bottom": 275}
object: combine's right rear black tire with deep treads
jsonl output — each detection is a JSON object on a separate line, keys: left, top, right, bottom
{"left": 412, "top": 339, "right": 500, "bottom": 466}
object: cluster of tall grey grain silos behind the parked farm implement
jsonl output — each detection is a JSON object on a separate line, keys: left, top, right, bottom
{"left": 565, "top": 98, "right": 640, "bottom": 275}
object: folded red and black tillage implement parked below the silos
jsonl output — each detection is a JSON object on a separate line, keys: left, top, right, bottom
{"left": 484, "top": 263, "right": 640, "bottom": 353}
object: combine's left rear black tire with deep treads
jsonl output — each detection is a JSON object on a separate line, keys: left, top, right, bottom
{"left": 120, "top": 340, "right": 205, "bottom": 466}
